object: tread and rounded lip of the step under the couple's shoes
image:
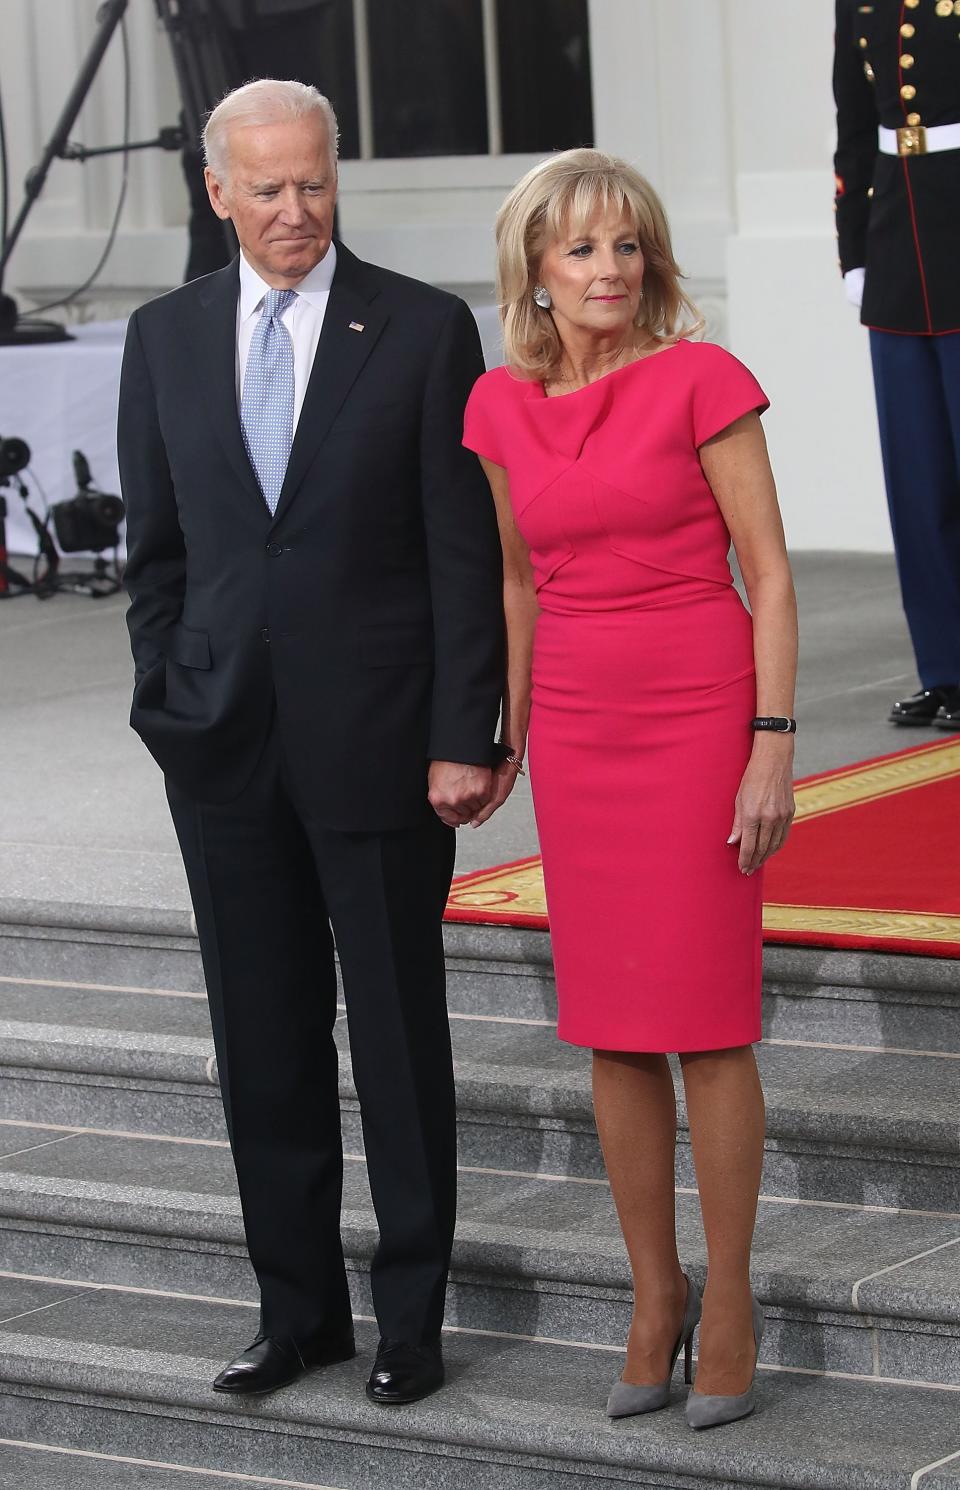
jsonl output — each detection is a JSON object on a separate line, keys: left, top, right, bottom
{"left": 0, "top": 1281, "right": 960, "bottom": 1490}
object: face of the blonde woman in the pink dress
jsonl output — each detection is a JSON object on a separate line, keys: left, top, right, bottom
{"left": 538, "top": 203, "right": 644, "bottom": 341}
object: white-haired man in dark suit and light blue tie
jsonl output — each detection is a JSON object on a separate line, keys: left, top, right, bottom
{"left": 119, "top": 80, "right": 510, "bottom": 1402}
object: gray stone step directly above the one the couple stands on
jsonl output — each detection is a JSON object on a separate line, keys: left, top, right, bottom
{"left": 0, "top": 1126, "right": 960, "bottom": 1387}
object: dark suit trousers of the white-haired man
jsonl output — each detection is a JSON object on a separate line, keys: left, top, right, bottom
{"left": 167, "top": 723, "right": 456, "bottom": 1342}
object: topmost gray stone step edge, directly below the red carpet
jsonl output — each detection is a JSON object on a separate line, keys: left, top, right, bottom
{"left": 0, "top": 900, "right": 960, "bottom": 1050}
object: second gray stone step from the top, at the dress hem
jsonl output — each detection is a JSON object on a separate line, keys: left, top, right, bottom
{"left": 0, "top": 983, "right": 960, "bottom": 1211}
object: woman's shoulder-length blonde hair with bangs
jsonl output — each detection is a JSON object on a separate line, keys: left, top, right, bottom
{"left": 496, "top": 149, "right": 704, "bottom": 378}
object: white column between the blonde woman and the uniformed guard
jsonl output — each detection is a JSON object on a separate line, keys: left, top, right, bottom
{"left": 724, "top": 0, "right": 891, "bottom": 551}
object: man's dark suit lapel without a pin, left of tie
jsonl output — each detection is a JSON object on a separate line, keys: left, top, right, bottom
{"left": 189, "top": 259, "right": 270, "bottom": 516}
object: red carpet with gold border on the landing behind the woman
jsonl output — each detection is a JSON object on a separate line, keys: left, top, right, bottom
{"left": 447, "top": 739, "right": 960, "bottom": 957}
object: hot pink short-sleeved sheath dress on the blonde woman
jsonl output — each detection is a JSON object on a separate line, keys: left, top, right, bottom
{"left": 464, "top": 341, "right": 768, "bottom": 1052}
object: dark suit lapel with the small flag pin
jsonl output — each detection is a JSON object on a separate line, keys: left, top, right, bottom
{"left": 274, "top": 243, "right": 389, "bottom": 520}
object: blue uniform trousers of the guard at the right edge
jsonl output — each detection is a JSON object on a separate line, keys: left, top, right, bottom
{"left": 871, "top": 331, "right": 960, "bottom": 688}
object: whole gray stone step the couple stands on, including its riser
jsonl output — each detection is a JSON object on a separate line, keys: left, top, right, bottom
{"left": 0, "top": 1280, "right": 960, "bottom": 1490}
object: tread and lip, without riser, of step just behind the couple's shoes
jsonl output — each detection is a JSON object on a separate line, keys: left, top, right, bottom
{"left": 0, "top": 1131, "right": 960, "bottom": 1326}
